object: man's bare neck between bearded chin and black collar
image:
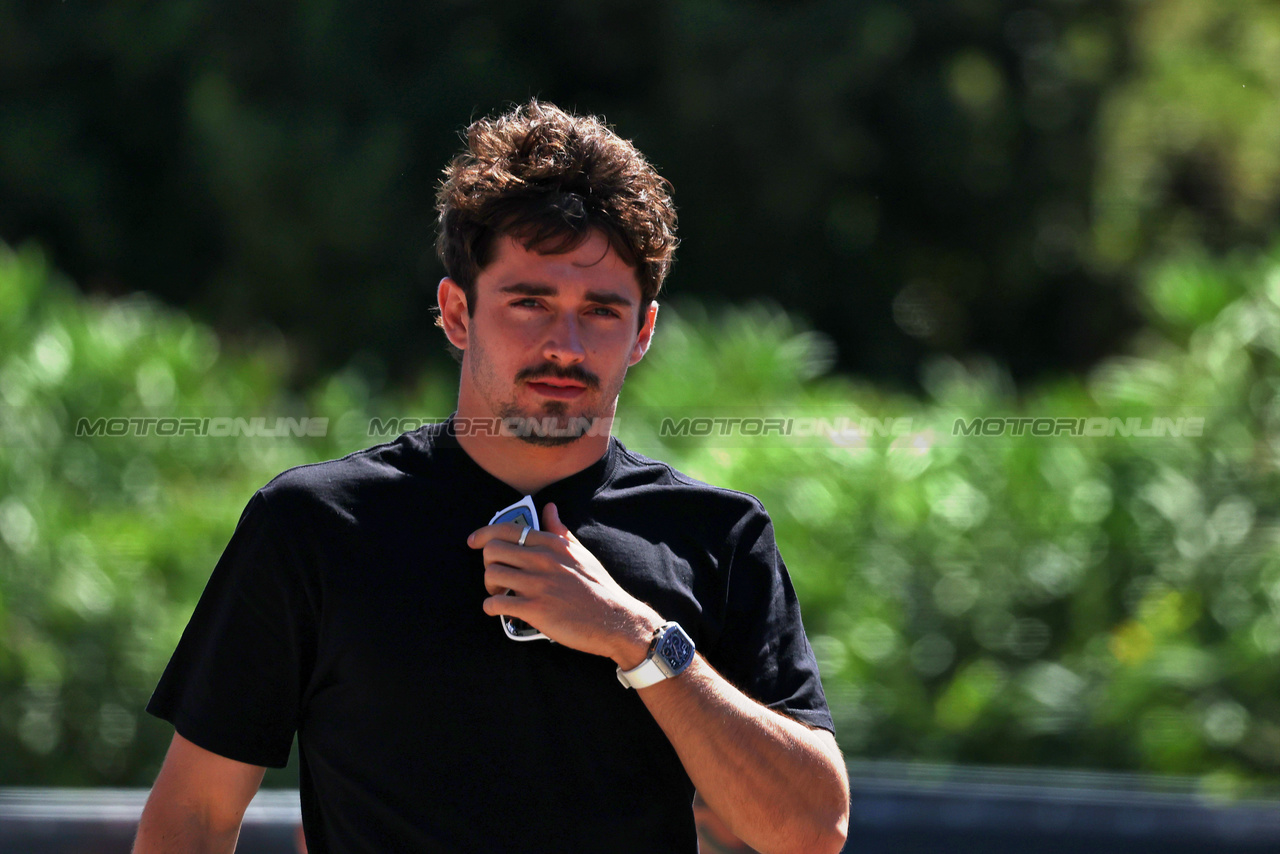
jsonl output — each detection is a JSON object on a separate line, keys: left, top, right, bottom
{"left": 457, "top": 402, "right": 613, "bottom": 495}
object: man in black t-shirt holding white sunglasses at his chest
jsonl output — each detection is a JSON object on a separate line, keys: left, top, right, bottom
{"left": 134, "top": 101, "right": 849, "bottom": 854}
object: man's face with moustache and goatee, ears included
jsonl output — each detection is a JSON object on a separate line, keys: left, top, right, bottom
{"left": 439, "top": 233, "right": 658, "bottom": 446}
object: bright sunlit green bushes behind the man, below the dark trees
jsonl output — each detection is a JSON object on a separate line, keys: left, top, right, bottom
{"left": 0, "top": 235, "right": 1280, "bottom": 793}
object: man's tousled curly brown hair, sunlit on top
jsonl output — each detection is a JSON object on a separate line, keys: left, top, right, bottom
{"left": 435, "top": 99, "right": 678, "bottom": 320}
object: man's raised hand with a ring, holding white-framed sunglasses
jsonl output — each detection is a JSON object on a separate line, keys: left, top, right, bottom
{"left": 467, "top": 504, "right": 664, "bottom": 670}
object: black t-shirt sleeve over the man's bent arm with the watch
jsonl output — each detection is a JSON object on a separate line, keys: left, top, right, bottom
{"left": 710, "top": 507, "right": 835, "bottom": 732}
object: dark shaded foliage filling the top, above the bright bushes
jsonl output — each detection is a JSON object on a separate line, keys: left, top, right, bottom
{"left": 0, "top": 0, "right": 1280, "bottom": 388}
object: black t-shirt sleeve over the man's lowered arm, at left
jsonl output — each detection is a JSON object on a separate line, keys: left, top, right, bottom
{"left": 147, "top": 492, "right": 315, "bottom": 768}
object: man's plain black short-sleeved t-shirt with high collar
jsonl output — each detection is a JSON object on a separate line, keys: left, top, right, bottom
{"left": 147, "top": 421, "right": 832, "bottom": 854}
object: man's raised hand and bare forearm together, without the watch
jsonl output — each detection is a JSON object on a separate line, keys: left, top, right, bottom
{"left": 467, "top": 504, "right": 849, "bottom": 854}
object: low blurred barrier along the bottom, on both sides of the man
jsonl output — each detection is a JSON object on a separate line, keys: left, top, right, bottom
{"left": 0, "top": 762, "right": 1280, "bottom": 854}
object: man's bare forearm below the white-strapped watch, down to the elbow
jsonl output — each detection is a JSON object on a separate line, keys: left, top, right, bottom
{"left": 639, "top": 656, "right": 849, "bottom": 854}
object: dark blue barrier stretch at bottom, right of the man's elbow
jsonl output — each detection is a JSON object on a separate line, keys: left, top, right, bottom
{"left": 845, "top": 762, "right": 1280, "bottom": 854}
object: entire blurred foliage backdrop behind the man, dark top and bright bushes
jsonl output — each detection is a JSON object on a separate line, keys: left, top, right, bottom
{"left": 0, "top": 0, "right": 1280, "bottom": 795}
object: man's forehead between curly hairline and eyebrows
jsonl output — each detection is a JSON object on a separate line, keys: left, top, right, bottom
{"left": 476, "top": 232, "right": 640, "bottom": 303}
